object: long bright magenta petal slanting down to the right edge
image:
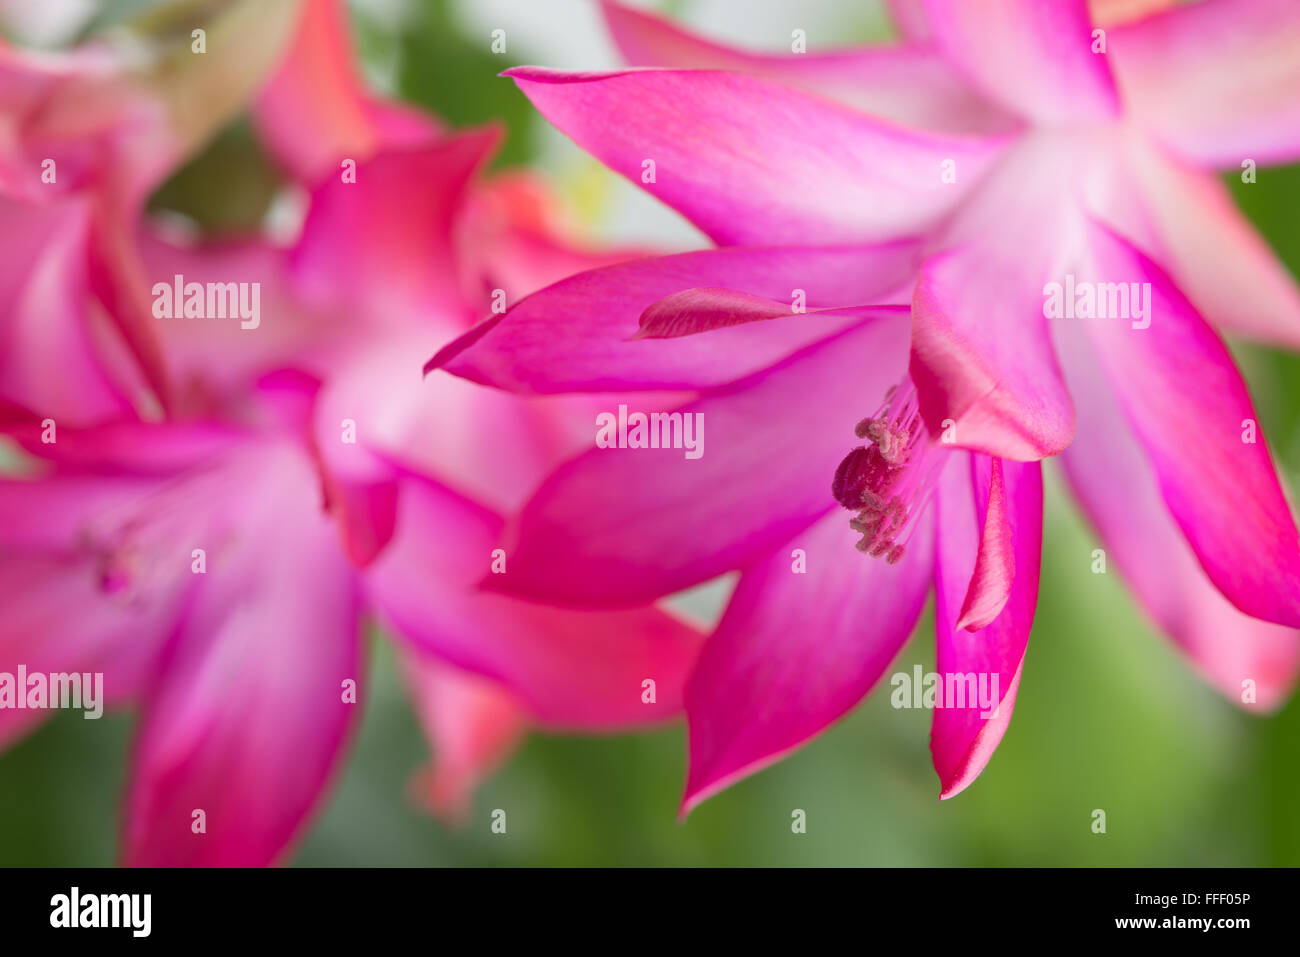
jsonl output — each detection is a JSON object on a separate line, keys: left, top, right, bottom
{"left": 1076, "top": 226, "right": 1300, "bottom": 627}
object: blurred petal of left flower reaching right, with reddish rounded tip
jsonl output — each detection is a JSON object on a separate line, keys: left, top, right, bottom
{"left": 365, "top": 479, "right": 702, "bottom": 731}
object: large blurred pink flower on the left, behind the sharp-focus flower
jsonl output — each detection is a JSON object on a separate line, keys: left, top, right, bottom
{"left": 0, "top": 3, "right": 699, "bottom": 865}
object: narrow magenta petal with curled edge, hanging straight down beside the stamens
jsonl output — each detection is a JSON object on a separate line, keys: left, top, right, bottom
{"left": 930, "top": 455, "right": 1043, "bottom": 798}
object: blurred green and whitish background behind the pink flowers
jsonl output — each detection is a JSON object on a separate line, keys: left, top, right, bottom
{"left": 0, "top": 0, "right": 1300, "bottom": 866}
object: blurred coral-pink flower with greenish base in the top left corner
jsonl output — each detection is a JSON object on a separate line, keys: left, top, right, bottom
{"left": 0, "top": 0, "right": 301, "bottom": 424}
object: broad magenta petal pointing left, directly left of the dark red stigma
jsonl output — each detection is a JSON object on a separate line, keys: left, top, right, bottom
{"left": 486, "top": 320, "right": 907, "bottom": 606}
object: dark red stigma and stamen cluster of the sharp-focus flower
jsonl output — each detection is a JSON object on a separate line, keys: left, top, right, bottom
{"left": 831, "top": 377, "right": 939, "bottom": 564}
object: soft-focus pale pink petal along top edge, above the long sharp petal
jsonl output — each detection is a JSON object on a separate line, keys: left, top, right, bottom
{"left": 601, "top": 0, "right": 1013, "bottom": 133}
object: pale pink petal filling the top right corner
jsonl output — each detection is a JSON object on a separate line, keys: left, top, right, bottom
{"left": 1108, "top": 0, "right": 1300, "bottom": 169}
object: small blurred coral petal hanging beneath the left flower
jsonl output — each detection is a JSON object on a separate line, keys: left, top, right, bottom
{"left": 403, "top": 654, "right": 527, "bottom": 822}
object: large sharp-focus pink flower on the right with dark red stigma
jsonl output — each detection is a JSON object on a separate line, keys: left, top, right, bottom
{"left": 429, "top": 0, "right": 1300, "bottom": 809}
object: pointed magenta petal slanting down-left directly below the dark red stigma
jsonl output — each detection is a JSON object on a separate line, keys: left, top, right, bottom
{"left": 681, "top": 509, "right": 935, "bottom": 814}
